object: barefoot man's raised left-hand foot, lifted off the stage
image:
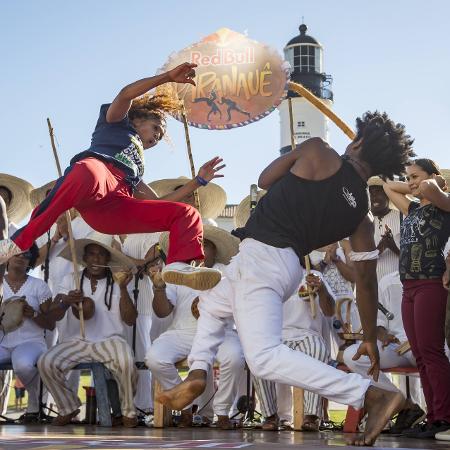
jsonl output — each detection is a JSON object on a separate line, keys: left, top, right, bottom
{"left": 156, "top": 370, "right": 206, "bottom": 411}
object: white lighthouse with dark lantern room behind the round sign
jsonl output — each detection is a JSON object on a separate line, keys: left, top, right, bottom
{"left": 279, "top": 24, "right": 333, "bottom": 154}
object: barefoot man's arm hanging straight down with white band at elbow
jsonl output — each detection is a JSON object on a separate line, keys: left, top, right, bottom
{"left": 350, "top": 215, "right": 380, "bottom": 381}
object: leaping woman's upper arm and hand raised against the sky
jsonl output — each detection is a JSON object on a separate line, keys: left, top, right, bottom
{"left": 106, "top": 62, "right": 197, "bottom": 123}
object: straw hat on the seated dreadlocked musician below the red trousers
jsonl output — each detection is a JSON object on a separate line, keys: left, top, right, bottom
{"left": 58, "top": 231, "right": 135, "bottom": 272}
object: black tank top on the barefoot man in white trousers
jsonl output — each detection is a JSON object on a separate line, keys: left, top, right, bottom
{"left": 233, "top": 158, "right": 370, "bottom": 258}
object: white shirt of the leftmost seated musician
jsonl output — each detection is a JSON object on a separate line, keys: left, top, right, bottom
{"left": 0, "top": 275, "right": 52, "bottom": 348}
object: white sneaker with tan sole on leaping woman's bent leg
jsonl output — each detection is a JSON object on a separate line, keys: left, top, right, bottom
{"left": 162, "top": 262, "right": 222, "bottom": 291}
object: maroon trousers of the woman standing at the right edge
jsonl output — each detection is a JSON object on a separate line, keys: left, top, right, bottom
{"left": 402, "top": 280, "right": 450, "bottom": 423}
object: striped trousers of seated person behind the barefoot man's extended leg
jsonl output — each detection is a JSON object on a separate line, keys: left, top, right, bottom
{"left": 253, "top": 334, "right": 330, "bottom": 422}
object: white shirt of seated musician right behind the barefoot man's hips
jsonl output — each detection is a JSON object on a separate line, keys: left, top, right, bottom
{"left": 282, "top": 270, "right": 335, "bottom": 341}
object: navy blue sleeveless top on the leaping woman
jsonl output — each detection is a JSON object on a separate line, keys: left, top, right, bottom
{"left": 70, "top": 104, "right": 144, "bottom": 190}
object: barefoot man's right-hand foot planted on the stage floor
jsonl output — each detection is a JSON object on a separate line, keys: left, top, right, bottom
{"left": 351, "top": 386, "right": 405, "bottom": 446}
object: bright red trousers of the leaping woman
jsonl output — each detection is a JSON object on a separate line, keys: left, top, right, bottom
{"left": 12, "top": 158, "right": 204, "bottom": 263}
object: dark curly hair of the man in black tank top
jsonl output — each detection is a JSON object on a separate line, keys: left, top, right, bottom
{"left": 355, "top": 111, "right": 416, "bottom": 179}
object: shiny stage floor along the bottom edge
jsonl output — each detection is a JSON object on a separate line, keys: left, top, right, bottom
{"left": 0, "top": 425, "right": 450, "bottom": 450}
